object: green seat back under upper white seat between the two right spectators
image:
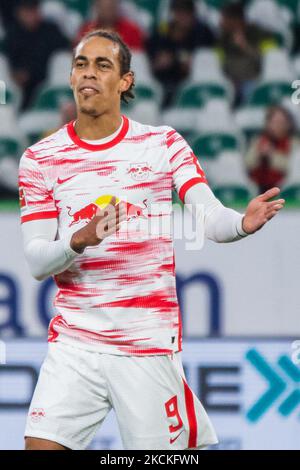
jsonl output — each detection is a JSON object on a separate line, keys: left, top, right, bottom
{"left": 175, "top": 83, "right": 230, "bottom": 108}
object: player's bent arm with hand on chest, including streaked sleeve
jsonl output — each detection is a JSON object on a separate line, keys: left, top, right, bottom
{"left": 19, "top": 150, "right": 124, "bottom": 281}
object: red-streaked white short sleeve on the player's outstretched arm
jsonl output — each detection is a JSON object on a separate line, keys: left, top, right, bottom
{"left": 167, "top": 128, "right": 207, "bottom": 202}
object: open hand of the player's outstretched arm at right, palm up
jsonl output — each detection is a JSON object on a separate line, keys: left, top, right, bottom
{"left": 243, "top": 187, "right": 285, "bottom": 234}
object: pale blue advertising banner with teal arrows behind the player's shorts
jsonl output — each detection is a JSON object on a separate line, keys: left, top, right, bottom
{"left": 0, "top": 339, "right": 300, "bottom": 450}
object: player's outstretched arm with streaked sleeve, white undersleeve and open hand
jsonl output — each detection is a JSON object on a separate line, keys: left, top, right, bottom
{"left": 166, "top": 128, "right": 284, "bottom": 243}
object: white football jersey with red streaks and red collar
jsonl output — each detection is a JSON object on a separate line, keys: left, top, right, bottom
{"left": 19, "top": 116, "right": 207, "bottom": 356}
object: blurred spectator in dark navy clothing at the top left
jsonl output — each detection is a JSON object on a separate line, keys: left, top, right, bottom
{"left": 4, "top": 0, "right": 69, "bottom": 108}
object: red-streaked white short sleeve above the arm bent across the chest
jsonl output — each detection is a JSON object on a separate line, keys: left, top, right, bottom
{"left": 19, "top": 149, "right": 58, "bottom": 224}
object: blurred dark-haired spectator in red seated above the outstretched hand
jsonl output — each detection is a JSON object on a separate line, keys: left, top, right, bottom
{"left": 246, "top": 106, "right": 300, "bottom": 192}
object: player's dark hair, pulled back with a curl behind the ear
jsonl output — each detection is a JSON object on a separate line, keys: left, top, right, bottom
{"left": 73, "top": 29, "right": 135, "bottom": 103}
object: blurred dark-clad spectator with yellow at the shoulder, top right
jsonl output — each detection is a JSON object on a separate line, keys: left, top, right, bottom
{"left": 219, "top": 3, "right": 276, "bottom": 106}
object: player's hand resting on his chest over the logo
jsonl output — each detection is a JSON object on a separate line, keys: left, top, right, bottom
{"left": 70, "top": 196, "right": 127, "bottom": 253}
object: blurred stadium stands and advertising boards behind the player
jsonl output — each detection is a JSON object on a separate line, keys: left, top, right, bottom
{"left": 0, "top": 0, "right": 300, "bottom": 449}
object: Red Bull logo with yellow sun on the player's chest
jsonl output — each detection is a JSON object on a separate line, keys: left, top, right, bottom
{"left": 67, "top": 194, "right": 147, "bottom": 227}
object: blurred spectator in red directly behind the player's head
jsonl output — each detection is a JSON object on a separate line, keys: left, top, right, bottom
{"left": 77, "top": 0, "right": 144, "bottom": 50}
